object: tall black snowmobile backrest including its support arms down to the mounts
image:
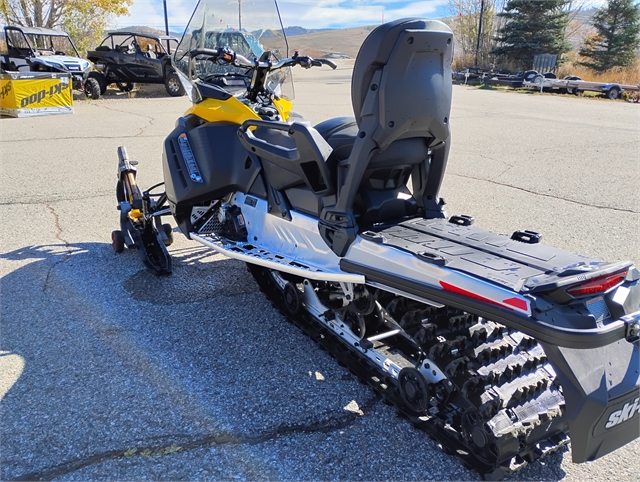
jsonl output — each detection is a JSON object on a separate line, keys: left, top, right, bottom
{"left": 319, "top": 18, "right": 453, "bottom": 256}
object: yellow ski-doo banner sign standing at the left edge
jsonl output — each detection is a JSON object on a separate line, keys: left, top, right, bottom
{"left": 0, "top": 72, "right": 73, "bottom": 117}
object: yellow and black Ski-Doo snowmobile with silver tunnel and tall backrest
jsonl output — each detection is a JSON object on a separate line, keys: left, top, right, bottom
{"left": 114, "top": 0, "right": 640, "bottom": 479}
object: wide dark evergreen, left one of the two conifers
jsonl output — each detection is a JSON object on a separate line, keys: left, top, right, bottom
{"left": 491, "top": 0, "right": 571, "bottom": 69}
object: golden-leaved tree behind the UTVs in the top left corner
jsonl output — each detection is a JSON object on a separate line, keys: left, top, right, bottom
{"left": 0, "top": 0, "right": 133, "bottom": 52}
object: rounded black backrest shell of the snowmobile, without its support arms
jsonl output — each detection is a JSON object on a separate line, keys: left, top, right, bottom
{"left": 351, "top": 18, "right": 453, "bottom": 148}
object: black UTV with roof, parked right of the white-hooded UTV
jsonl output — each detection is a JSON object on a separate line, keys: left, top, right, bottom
{"left": 87, "top": 32, "right": 184, "bottom": 96}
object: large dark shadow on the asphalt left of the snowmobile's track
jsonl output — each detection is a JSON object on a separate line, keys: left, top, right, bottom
{"left": 0, "top": 243, "right": 564, "bottom": 480}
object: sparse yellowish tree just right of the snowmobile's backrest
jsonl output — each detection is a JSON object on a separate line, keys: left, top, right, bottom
{"left": 448, "top": 0, "right": 503, "bottom": 66}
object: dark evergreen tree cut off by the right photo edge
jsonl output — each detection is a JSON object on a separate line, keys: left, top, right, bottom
{"left": 580, "top": 0, "right": 640, "bottom": 72}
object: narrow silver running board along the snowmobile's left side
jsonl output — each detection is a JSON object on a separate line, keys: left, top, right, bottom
{"left": 189, "top": 233, "right": 365, "bottom": 284}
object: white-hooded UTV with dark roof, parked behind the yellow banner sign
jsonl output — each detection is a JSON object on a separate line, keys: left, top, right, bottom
{"left": 0, "top": 26, "right": 100, "bottom": 99}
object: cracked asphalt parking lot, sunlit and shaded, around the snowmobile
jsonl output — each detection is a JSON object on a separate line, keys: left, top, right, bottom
{"left": 0, "top": 61, "right": 640, "bottom": 482}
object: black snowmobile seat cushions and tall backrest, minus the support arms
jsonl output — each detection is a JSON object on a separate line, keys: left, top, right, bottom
{"left": 316, "top": 19, "right": 452, "bottom": 233}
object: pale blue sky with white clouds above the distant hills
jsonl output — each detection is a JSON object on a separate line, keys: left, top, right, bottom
{"left": 111, "top": 0, "right": 448, "bottom": 32}
